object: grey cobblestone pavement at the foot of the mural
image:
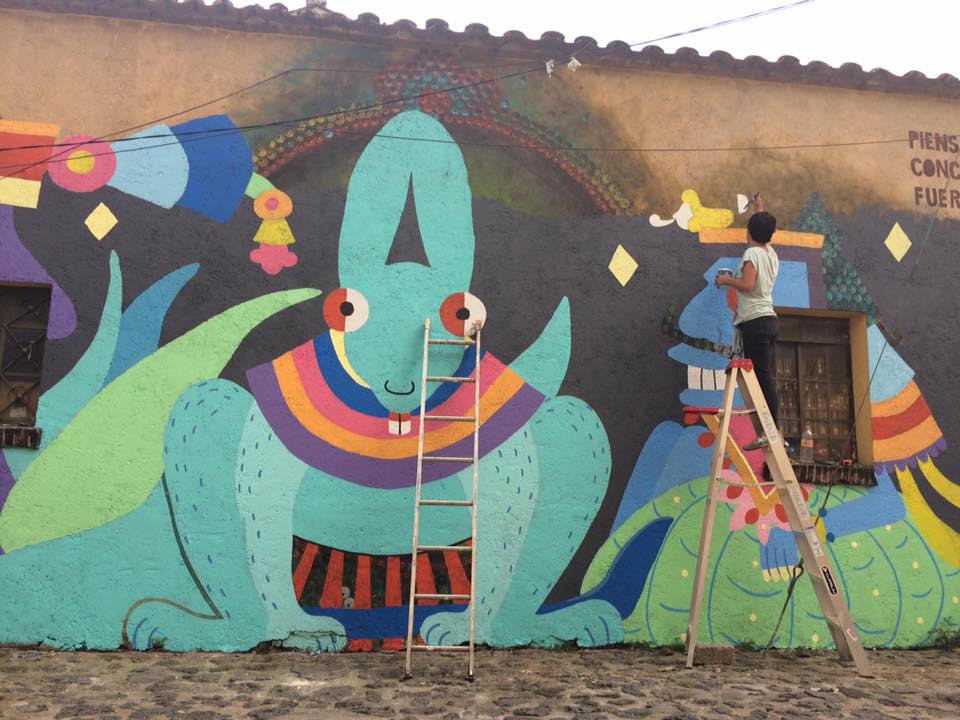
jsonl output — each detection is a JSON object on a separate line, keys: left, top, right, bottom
{"left": 0, "top": 648, "right": 960, "bottom": 720}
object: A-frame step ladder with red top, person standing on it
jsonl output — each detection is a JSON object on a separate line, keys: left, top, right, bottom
{"left": 684, "top": 360, "right": 873, "bottom": 677}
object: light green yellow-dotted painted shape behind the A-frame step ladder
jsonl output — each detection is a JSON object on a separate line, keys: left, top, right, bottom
{"left": 583, "top": 478, "right": 960, "bottom": 648}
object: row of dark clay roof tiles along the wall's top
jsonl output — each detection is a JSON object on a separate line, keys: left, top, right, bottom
{"left": 0, "top": 0, "right": 960, "bottom": 99}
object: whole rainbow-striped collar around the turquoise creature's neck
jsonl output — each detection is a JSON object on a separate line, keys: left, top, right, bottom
{"left": 247, "top": 333, "right": 544, "bottom": 488}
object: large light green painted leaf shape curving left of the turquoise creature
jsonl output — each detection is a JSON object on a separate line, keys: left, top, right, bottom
{"left": 0, "top": 289, "right": 320, "bottom": 552}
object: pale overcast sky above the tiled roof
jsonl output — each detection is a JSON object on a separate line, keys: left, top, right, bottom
{"left": 231, "top": 0, "right": 960, "bottom": 77}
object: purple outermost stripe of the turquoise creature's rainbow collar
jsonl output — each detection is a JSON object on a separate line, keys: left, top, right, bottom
{"left": 247, "top": 363, "right": 544, "bottom": 489}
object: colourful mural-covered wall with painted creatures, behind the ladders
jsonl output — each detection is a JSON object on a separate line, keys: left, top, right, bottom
{"left": 0, "top": 8, "right": 960, "bottom": 651}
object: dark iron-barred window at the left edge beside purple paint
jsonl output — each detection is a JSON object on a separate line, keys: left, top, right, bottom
{"left": 0, "top": 284, "right": 51, "bottom": 447}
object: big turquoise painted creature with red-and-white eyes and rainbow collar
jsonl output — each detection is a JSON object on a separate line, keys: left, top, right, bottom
{"left": 0, "top": 112, "right": 624, "bottom": 651}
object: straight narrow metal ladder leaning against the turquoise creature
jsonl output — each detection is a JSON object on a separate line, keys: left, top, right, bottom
{"left": 403, "top": 318, "right": 480, "bottom": 680}
